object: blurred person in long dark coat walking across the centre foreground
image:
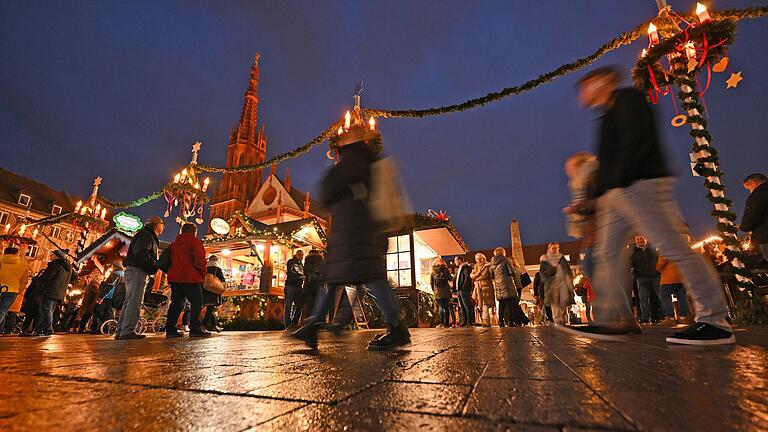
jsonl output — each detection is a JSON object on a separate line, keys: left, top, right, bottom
{"left": 294, "top": 123, "right": 411, "bottom": 350}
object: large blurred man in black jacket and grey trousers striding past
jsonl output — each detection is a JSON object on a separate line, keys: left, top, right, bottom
{"left": 562, "top": 67, "right": 735, "bottom": 345}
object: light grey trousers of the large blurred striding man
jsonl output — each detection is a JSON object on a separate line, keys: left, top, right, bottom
{"left": 592, "top": 177, "right": 731, "bottom": 331}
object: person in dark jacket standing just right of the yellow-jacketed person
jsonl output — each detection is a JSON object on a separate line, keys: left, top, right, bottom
{"left": 33, "top": 249, "right": 76, "bottom": 336}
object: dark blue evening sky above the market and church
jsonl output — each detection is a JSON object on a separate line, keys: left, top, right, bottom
{"left": 0, "top": 0, "right": 768, "bottom": 249}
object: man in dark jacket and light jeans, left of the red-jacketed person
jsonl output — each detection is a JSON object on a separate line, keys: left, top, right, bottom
{"left": 115, "top": 216, "right": 165, "bottom": 340}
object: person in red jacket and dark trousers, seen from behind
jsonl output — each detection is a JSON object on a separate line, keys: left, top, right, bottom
{"left": 165, "top": 223, "right": 211, "bottom": 338}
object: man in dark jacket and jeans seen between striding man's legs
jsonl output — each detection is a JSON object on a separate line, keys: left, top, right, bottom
{"left": 632, "top": 234, "right": 660, "bottom": 323}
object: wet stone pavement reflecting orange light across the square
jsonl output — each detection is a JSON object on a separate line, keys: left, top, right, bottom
{"left": 0, "top": 327, "right": 768, "bottom": 432}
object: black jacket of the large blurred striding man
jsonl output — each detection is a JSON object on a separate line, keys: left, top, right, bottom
{"left": 597, "top": 88, "right": 670, "bottom": 196}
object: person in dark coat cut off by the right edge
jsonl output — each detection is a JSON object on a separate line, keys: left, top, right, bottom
{"left": 740, "top": 173, "right": 768, "bottom": 260}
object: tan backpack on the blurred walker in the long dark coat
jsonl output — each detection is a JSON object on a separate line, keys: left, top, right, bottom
{"left": 368, "top": 156, "right": 413, "bottom": 231}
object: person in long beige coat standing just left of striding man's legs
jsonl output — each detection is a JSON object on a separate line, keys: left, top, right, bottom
{"left": 539, "top": 243, "right": 576, "bottom": 325}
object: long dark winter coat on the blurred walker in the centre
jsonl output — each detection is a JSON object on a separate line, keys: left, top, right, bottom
{"left": 320, "top": 142, "right": 387, "bottom": 284}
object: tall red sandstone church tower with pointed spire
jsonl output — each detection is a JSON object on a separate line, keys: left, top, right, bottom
{"left": 211, "top": 54, "right": 267, "bottom": 226}
